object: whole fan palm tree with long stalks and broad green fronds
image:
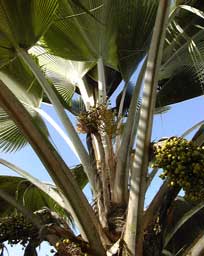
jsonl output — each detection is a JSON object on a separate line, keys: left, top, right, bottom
{"left": 0, "top": 0, "right": 204, "bottom": 256}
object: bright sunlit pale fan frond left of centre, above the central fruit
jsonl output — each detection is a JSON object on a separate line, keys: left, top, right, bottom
{"left": 29, "top": 47, "right": 95, "bottom": 108}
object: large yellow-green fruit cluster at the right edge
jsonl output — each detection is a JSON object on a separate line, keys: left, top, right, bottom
{"left": 153, "top": 137, "right": 204, "bottom": 201}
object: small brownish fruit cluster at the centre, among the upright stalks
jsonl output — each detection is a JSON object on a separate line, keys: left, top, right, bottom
{"left": 77, "top": 103, "right": 117, "bottom": 135}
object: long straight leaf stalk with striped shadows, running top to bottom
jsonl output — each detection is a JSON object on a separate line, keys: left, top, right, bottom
{"left": 124, "top": 0, "right": 171, "bottom": 255}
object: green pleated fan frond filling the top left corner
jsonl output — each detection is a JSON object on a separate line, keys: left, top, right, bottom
{"left": 0, "top": 0, "right": 57, "bottom": 49}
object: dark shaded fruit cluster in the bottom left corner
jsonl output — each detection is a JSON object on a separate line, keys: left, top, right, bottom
{"left": 0, "top": 214, "right": 38, "bottom": 246}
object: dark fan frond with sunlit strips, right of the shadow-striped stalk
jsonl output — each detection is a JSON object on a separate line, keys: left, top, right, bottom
{"left": 156, "top": 1, "right": 204, "bottom": 107}
